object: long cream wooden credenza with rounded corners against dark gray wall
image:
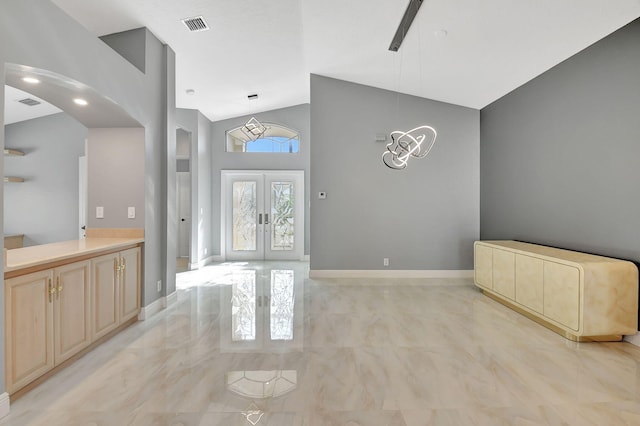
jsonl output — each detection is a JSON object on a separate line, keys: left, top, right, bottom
{"left": 474, "top": 241, "right": 638, "bottom": 341}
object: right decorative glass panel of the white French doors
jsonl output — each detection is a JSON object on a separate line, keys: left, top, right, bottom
{"left": 271, "top": 182, "right": 295, "bottom": 250}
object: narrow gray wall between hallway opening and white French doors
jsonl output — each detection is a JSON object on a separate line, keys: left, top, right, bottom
{"left": 176, "top": 109, "right": 213, "bottom": 268}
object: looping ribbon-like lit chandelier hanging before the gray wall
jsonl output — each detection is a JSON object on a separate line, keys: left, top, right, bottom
{"left": 382, "top": 126, "right": 438, "bottom": 170}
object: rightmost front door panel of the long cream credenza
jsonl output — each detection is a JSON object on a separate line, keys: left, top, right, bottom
{"left": 543, "top": 261, "right": 580, "bottom": 331}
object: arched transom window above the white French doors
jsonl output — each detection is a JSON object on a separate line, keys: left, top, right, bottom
{"left": 227, "top": 117, "right": 300, "bottom": 154}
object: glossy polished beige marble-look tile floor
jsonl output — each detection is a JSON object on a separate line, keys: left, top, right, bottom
{"left": 0, "top": 262, "right": 640, "bottom": 426}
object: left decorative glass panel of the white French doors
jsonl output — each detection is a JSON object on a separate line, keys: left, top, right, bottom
{"left": 232, "top": 181, "right": 258, "bottom": 251}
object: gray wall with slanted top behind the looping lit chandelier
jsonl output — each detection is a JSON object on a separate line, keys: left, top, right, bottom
{"left": 311, "top": 75, "right": 480, "bottom": 270}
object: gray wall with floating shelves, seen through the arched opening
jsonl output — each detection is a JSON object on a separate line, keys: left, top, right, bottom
{"left": 4, "top": 113, "right": 87, "bottom": 246}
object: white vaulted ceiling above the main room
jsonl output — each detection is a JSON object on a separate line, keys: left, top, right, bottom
{"left": 36, "top": 0, "right": 640, "bottom": 120}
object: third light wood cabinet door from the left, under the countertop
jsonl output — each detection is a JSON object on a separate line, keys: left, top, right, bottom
{"left": 91, "top": 253, "right": 119, "bottom": 340}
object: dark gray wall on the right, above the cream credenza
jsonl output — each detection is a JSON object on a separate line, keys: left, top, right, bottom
{"left": 480, "top": 20, "right": 640, "bottom": 261}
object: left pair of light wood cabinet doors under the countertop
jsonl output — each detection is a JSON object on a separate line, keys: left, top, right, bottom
{"left": 5, "top": 262, "right": 91, "bottom": 392}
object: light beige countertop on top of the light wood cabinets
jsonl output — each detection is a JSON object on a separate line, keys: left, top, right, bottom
{"left": 4, "top": 238, "right": 144, "bottom": 273}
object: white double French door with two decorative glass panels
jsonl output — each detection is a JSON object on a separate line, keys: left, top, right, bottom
{"left": 222, "top": 170, "right": 304, "bottom": 260}
